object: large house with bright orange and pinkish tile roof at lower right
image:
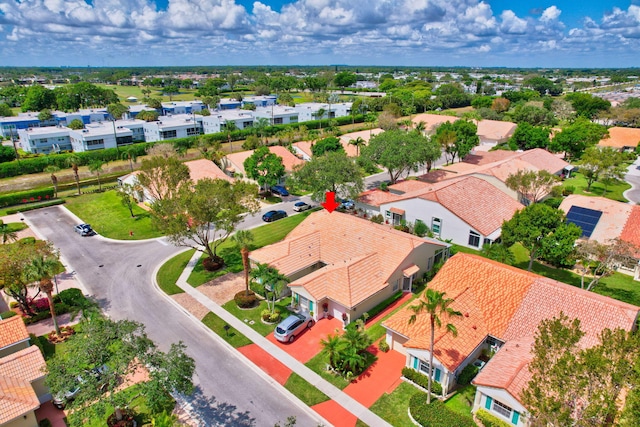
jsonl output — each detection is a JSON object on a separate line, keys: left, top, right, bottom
{"left": 382, "top": 253, "right": 640, "bottom": 426}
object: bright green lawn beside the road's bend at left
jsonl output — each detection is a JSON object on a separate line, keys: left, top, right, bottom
{"left": 65, "top": 190, "right": 162, "bottom": 240}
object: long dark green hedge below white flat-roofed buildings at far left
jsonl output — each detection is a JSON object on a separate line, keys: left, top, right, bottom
{"left": 0, "top": 142, "right": 153, "bottom": 178}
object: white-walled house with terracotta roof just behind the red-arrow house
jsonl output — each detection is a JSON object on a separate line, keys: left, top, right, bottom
{"left": 357, "top": 176, "right": 523, "bottom": 249}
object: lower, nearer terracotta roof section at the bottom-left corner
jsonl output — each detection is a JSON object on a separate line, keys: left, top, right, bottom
{"left": 0, "top": 346, "right": 46, "bottom": 424}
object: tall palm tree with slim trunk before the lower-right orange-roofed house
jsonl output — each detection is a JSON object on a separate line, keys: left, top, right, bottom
{"left": 409, "top": 288, "right": 462, "bottom": 405}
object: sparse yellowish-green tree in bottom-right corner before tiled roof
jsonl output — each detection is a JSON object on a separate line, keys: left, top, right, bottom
{"left": 522, "top": 313, "right": 640, "bottom": 426}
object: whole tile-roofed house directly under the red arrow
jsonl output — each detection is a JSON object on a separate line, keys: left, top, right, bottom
{"left": 249, "top": 210, "right": 449, "bottom": 321}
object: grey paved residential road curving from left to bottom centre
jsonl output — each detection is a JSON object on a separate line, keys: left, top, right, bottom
{"left": 24, "top": 206, "right": 316, "bottom": 426}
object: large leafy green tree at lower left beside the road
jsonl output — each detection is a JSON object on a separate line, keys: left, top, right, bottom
{"left": 45, "top": 315, "right": 195, "bottom": 425}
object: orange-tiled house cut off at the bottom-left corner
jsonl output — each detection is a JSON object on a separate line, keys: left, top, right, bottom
{"left": 0, "top": 316, "right": 51, "bottom": 427}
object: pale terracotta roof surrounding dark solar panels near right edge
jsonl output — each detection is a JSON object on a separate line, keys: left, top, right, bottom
{"left": 559, "top": 194, "right": 640, "bottom": 243}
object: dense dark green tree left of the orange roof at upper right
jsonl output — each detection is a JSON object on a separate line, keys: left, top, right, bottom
{"left": 549, "top": 117, "right": 609, "bottom": 159}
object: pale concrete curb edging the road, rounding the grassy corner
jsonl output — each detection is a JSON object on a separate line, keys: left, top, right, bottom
{"left": 152, "top": 248, "right": 331, "bottom": 426}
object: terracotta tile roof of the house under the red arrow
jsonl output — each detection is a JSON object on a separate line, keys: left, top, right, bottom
{"left": 250, "top": 210, "right": 444, "bottom": 307}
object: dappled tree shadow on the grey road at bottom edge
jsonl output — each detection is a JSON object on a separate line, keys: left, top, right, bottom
{"left": 177, "top": 387, "right": 256, "bottom": 427}
